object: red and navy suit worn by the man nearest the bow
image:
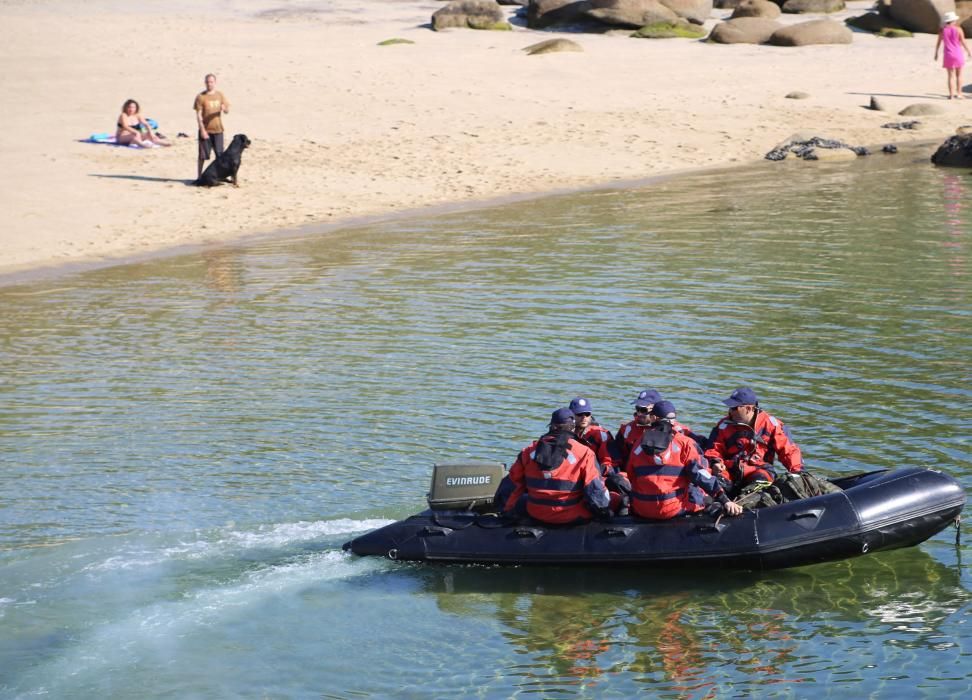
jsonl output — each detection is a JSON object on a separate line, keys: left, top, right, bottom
{"left": 705, "top": 408, "right": 803, "bottom": 486}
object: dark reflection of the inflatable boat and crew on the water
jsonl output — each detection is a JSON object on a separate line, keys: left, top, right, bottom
{"left": 422, "top": 549, "right": 970, "bottom": 698}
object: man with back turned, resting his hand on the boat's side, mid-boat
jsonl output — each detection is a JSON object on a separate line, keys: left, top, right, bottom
{"left": 628, "top": 401, "right": 743, "bottom": 520}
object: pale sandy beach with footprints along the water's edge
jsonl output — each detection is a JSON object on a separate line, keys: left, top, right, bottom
{"left": 0, "top": 0, "right": 972, "bottom": 279}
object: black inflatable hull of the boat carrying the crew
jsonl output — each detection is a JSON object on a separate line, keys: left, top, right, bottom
{"left": 344, "top": 468, "right": 965, "bottom": 571}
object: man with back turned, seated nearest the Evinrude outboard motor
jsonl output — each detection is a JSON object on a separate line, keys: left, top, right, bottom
{"left": 503, "top": 408, "right": 611, "bottom": 525}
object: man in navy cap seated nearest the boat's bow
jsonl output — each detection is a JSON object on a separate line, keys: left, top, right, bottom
{"left": 705, "top": 386, "right": 803, "bottom": 492}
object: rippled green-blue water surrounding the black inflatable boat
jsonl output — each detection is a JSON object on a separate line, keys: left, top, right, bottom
{"left": 0, "top": 153, "right": 972, "bottom": 700}
